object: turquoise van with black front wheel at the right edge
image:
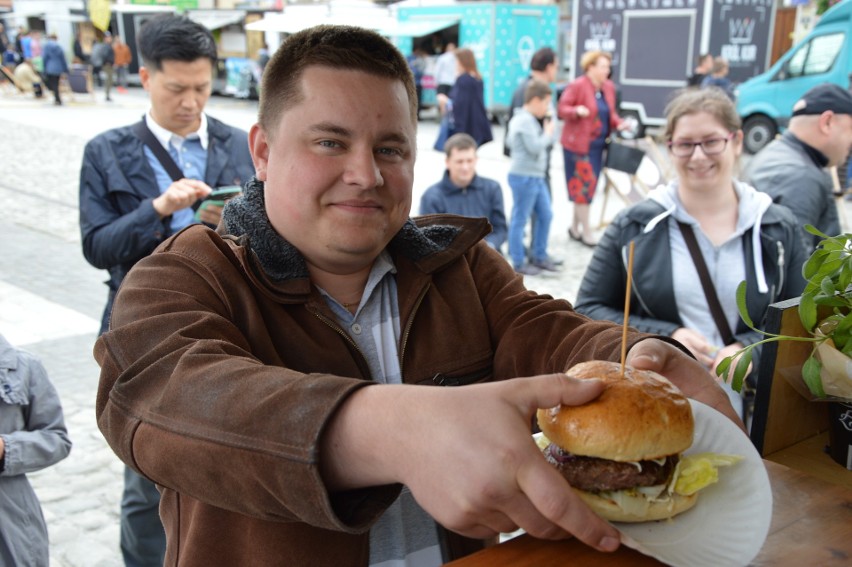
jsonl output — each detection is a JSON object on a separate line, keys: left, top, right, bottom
{"left": 737, "top": 0, "right": 852, "bottom": 153}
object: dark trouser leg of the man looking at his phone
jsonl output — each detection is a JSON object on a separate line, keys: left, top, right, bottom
{"left": 121, "top": 467, "right": 166, "bottom": 567}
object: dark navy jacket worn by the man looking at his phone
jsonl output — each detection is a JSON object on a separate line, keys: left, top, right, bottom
{"left": 80, "top": 116, "right": 254, "bottom": 330}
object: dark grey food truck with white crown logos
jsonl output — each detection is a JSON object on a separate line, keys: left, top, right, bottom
{"left": 571, "top": 0, "right": 776, "bottom": 135}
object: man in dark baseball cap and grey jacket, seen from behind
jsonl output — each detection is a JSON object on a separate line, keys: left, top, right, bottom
{"left": 745, "top": 83, "right": 852, "bottom": 251}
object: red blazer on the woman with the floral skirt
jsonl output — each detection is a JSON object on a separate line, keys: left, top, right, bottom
{"left": 556, "top": 75, "right": 621, "bottom": 156}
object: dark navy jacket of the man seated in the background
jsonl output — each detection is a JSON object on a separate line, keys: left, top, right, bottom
{"left": 420, "top": 171, "right": 508, "bottom": 250}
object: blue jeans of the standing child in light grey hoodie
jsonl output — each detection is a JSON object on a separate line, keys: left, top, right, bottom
{"left": 509, "top": 173, "right": 553, "bottom": 268}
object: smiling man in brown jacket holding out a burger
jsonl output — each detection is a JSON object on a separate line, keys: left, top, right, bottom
{"left": 95, "top": 27, "right": 737, "bottom": 566}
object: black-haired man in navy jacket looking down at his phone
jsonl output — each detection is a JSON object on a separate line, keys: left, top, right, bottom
{"left": 80, "top": 14, "right": 254, "bottom": 566}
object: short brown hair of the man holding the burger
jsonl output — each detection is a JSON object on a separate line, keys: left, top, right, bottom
{"left": 258, "top": 25, "right": 417, "bottom": 140}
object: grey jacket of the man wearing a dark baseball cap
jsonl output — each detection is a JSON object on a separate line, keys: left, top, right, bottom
{"left": 747, "top": 130, "right": 841, "bottom": 253}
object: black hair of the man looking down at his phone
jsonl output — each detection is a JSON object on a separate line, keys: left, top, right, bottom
{"left": 137, "top": 14, "right": 217, "bottom": 71}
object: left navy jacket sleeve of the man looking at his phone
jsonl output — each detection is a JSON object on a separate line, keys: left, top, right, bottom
{"left": 80, "top": 137, "right": 171, "bottom": 269}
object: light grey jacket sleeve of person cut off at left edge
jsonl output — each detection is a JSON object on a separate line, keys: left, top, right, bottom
{"left": 0, "top": 351, "right": 71, "bottom": 476}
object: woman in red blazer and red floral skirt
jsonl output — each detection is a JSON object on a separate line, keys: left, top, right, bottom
{"left": 557, "top": 51, "right": 627, "bottom": 247}
